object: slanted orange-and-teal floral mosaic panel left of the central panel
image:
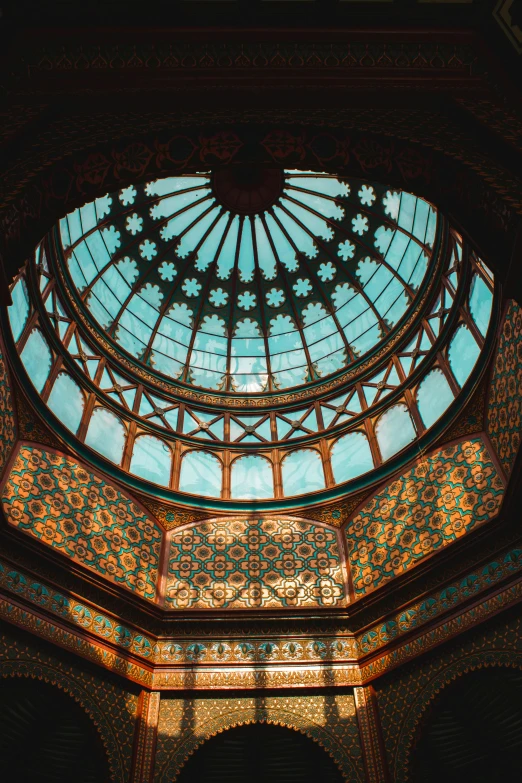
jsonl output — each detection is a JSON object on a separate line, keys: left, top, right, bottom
{"left": 2, "top": 446, "right": 162, "bottom": 600}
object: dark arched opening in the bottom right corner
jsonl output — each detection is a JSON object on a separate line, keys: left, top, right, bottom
{"left": 411, "top": 668, "right": 522, "bottom": 783}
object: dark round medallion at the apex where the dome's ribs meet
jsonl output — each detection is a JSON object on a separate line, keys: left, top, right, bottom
{"left": 212, "top": 165, "right": 284, "bottom": 215}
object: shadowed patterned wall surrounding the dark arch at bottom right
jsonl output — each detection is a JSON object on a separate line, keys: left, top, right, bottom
{"left": 374, "top": 617, "right": 522, "bottom": 783}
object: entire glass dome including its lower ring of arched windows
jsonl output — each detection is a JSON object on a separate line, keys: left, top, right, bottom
{"left": 9, "top": 167, "right": 495, "bottom": 509}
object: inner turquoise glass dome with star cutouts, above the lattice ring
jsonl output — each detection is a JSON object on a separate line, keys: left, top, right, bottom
{"left": 60, "top": 166, "right": 437, "bottom": 394}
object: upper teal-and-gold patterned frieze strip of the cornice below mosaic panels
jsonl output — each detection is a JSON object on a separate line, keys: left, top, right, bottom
{"left": 0, "top": 547, "right": 522, "bottom": 672}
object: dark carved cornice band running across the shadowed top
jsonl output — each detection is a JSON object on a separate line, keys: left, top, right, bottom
{"left": 5, "top": 38, "right": 484, "bottom": 94}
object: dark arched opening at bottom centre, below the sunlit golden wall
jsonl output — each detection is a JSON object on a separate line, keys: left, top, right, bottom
{"left": 177, "top": 723, "right": 343, "bottom": 783}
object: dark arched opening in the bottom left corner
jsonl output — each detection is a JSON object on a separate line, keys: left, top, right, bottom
{"left": 0, "top": 678, "right": 111, "bottom": 783}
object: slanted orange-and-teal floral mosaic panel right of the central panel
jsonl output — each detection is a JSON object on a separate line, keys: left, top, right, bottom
{"left": 346, "top": 438, "right": 504, "bottom": 597}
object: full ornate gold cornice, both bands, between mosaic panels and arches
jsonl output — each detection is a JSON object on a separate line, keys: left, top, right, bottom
{"left": 0, "top": 548, "right": 522, "bottom": 690}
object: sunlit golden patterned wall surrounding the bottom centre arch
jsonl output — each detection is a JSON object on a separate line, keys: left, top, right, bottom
{"left": 154, "top": 693, "right": 365, "bottom": 783}
